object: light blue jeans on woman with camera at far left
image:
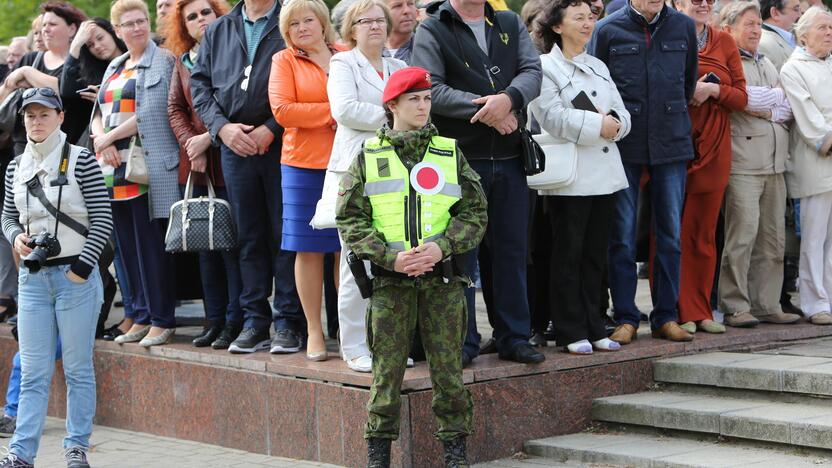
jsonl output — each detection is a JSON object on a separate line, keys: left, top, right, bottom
{"left": 9, "top": 265, "right": 104, "bottom": 463}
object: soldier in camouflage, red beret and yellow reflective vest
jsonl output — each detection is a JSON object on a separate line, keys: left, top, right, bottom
{"left": 336, "top": 67, "right": 487, "bottom": 467}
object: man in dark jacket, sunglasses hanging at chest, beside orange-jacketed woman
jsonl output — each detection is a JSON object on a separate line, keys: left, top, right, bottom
{"left": 191, "top": 0, "right": 306, "bottom": 353}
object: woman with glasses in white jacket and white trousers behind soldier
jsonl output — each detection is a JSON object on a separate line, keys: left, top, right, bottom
{"left": 327, "top": 0, "right": 407, "bottom": 372}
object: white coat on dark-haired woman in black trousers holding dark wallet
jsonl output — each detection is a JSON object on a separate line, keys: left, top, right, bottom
{"left": 529, "top": 45, "right": 630, "bottom": 196}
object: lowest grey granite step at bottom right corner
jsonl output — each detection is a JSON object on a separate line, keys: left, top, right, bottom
{"left": 528, "top": 433, "right": 832, "bottom": 468}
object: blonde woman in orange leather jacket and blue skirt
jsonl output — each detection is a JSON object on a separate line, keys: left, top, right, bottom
{"left": 269, "top": 0, "right": 340, "bottom": 361}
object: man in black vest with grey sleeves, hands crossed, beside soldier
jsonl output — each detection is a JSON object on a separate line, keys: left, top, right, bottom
{"left": 411, "top": 0, "right": 545, "bottom": 363}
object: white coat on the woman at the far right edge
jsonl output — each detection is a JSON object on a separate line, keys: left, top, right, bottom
{"left": 780, "top": 47, "right": 832, "bottom": 198}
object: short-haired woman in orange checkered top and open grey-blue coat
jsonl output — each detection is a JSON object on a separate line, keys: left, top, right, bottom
{"left": 90, "top": 0, "right": 180, "bottom": 347}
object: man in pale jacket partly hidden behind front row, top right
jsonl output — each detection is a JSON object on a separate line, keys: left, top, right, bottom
{"left": 759, "top": 0, "right": 800, "bottom": 71}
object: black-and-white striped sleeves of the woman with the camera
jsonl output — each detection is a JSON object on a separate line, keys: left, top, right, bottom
{"left": 2, "top": 149, "right": 113, "bottom": 278}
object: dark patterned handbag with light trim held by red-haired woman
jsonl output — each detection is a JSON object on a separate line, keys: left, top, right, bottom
{"left": 165, "top": 174, "right": 237, "bottom": 252}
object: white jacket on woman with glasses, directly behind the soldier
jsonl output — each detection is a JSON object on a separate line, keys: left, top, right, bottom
{"left": 326, "top": 47, "right": 407, "bottom": 172}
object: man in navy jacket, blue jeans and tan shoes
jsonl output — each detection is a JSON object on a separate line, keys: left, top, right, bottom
{"left": 587, "top": 0, "right": 698, "bottom": 344}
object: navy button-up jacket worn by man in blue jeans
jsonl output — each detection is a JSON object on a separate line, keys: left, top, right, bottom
{"left": 587, "top": 4, "right": 698, "bottom": 165}
